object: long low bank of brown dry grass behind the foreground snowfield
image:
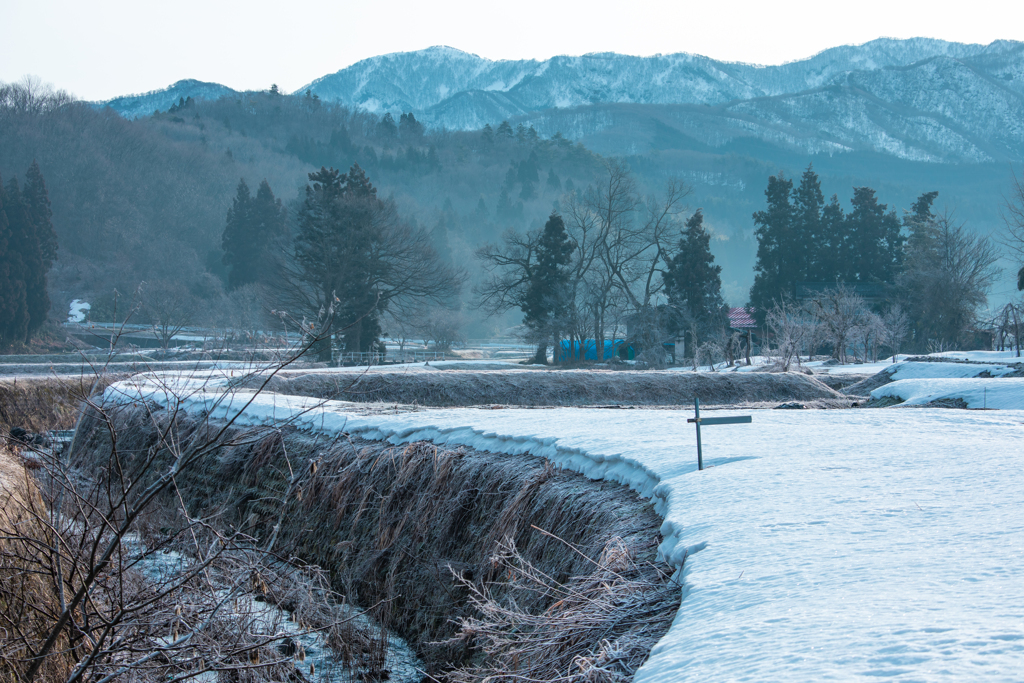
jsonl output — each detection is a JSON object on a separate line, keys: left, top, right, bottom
{"left": 250, "top": 371, "right": 842, "bottom": 407}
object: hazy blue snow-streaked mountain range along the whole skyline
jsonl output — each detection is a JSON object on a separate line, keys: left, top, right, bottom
{"left": 101, "top": 38, "right": 1024, "bottom": 163}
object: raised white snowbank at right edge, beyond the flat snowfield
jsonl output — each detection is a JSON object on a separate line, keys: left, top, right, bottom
{"left": 871, "top": 376, "right": 1024, "bottom": 410}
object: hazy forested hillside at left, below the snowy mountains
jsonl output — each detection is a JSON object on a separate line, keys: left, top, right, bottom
{"left": 0, "top": 86, "right": 602, "bottom": 335}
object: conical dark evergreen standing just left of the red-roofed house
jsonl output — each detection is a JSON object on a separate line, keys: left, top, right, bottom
{"left": 663, "top": 209, "right": 725, "bottom": 348}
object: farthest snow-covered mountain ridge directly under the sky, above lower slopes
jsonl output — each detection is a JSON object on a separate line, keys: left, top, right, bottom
{"left": 301, "top": 38, "right": 1016, "bottom": 118}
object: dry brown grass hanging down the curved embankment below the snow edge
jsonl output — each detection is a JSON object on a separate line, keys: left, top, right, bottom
{"left": 74, "top": 415, "right": 679, "bottom": 680}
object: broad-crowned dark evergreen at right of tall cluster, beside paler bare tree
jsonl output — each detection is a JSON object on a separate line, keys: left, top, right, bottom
{"left": 847, "top": 187, "right": 903, "bottom": 283}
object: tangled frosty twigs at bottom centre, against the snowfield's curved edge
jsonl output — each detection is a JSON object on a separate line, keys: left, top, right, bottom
{"left": 450, "top": 538, "right": 679, "bottom": 683}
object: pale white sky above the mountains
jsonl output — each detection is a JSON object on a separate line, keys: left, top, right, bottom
{"left": 6, "top": 0, "right": 1024, "bottom": 99}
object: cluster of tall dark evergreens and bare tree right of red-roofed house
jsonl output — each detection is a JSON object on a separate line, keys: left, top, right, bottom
{"left": 749, "top": 166, "right": 999, "bottom": 354}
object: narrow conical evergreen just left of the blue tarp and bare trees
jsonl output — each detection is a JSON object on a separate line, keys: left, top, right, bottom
{"left": 522, "top": 213, "right": 575, "bottom": 362}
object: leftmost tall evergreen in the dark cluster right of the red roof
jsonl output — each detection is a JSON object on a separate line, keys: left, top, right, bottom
{"left": 751, "top": 173, "right": 797, "bottom": 323}
